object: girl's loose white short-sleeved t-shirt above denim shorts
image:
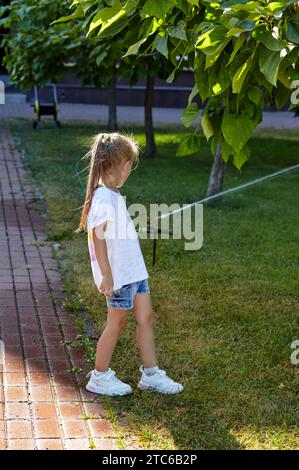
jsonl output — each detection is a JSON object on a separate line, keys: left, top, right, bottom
{"left": 87, "top": 187, "right": 148, "bottom": 291}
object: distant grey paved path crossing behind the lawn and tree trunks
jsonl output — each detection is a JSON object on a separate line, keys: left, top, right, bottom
{"left": 0, "top": 96, "right": 299, "bottom": 129}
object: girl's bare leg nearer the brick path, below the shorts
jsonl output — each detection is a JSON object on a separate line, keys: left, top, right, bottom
{"left": 95, "top": 307, "right": 128, "bottom": 372}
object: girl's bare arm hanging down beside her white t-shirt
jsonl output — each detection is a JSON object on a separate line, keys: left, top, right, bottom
{"left": 93, "top": 222, "right": 113, "bottom": 297}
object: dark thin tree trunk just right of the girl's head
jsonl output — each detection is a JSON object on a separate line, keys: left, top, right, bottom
{"left": 144, "top": 68, "right": 156, "bottom": 158}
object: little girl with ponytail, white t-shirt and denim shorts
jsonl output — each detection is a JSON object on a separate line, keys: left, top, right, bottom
{"left": 77, "top": 132, "right": 183, "bottom": 396}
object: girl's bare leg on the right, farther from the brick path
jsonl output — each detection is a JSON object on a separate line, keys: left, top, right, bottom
{"left": 133, "top": 293, "right": 157, "bottom": 368}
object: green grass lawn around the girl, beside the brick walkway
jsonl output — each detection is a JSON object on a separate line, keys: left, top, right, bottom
{"left": 11, "top": 120, "right": 299, "bottom": 449}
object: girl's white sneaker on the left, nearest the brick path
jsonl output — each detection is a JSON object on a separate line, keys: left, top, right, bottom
{"left": 86, "top": 368, "right": 132, "bottom": 397}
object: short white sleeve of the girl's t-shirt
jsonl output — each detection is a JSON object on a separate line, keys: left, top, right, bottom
{"left": 88, "top": 192, "right": 115, "bottom": 230}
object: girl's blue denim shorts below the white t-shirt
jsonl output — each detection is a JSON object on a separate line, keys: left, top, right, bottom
{"left": 106, "top": 279, "right": 150, "bottom": 310}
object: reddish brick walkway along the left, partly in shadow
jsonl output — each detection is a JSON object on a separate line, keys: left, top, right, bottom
{"left": 0, "top": 128, "right": 115, "bottom": 449}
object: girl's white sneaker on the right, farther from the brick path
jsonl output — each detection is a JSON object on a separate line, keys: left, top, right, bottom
{"left": 137, "top": 366, "right": 184, "bottom": 394}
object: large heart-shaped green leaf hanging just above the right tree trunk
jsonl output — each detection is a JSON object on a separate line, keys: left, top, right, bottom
{"left": 221, "top": 114, "right": 254, "bottom": 153}
